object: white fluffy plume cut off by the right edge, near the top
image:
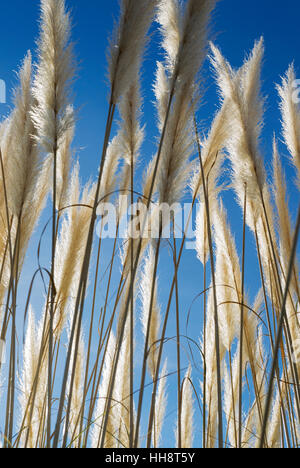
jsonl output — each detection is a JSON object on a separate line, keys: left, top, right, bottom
{"left": 277, "top": 65, "right": 300, "bottom": 188}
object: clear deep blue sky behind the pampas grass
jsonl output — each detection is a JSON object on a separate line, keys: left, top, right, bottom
{"left": 0, "top": 0, "right": 300, "bottom": 448}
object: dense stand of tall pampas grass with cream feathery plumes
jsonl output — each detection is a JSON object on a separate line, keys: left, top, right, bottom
{"left": 0, "top": 0, "right": 300, "bottom": 449}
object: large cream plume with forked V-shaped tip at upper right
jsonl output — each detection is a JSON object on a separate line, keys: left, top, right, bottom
{"left": 212, "top": 40, "right": 276, "bottom": 308}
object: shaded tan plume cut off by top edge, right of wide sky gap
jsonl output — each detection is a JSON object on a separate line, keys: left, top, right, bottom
{"left": 109, "top": 0, "right": 158, "bottom": 104}
